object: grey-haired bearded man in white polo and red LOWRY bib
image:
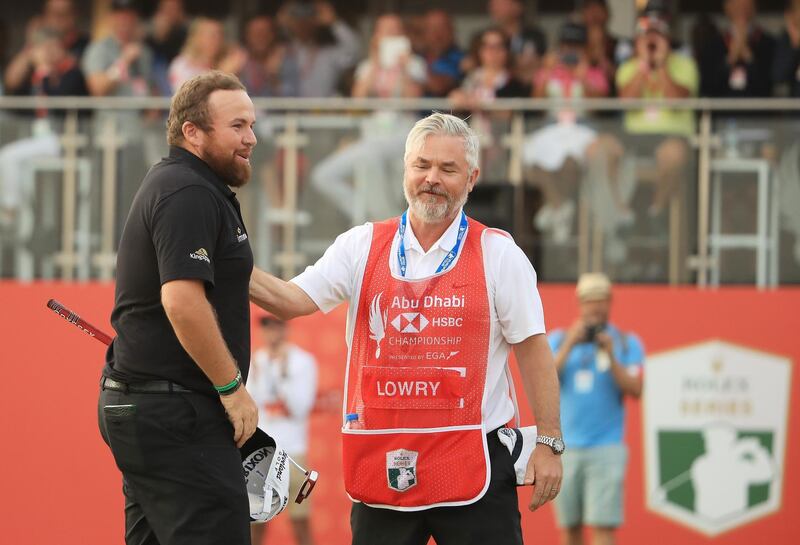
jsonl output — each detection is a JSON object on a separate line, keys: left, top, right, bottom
{"left": 251, "top": 113, "right": 563, "bottom": 545}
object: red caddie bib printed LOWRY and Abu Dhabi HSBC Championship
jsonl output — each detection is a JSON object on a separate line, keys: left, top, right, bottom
{"left": 342, "top": 219, "right": 491, "bottom": 510}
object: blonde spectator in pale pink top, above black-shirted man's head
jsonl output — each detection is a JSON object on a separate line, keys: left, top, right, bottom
{"left": 169, "top": 17, "right": 246, "bottom": 92}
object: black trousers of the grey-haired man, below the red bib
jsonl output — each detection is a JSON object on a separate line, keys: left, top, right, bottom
{"left": 350, "top": 432, "right": 522, "bottom": 545}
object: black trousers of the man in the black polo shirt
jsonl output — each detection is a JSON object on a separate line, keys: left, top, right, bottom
{"left": 98, "top": 390, "right": 250, "bottom": 545}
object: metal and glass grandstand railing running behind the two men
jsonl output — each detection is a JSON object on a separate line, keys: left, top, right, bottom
{"left": 0, "top": 97, "right": 800, "bottom": 288}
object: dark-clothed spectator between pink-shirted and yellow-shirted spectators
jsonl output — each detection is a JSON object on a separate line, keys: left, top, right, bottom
{"left": 579, "top": 0, "right": 633, "bottom": 95}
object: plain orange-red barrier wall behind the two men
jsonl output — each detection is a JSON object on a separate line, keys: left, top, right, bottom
{"left": 0, "top": 283, "right": 800, "bottom": 545}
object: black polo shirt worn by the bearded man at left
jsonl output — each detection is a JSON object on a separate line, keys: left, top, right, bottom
{"left": 104, "top": 147, "right": 253, "bottom": 395}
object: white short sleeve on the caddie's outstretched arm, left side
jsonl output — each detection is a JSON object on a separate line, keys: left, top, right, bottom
{"left": 291, "top": 224, "right": 372, "bottom": 314}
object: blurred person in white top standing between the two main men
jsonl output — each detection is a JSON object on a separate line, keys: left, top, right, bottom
{"left": 247, "top": 315, "right": 317, "bottom": 545}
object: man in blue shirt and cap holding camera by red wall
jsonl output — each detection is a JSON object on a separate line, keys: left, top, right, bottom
{"left": 548, "top": 273, "right": 644, "bottom": 545}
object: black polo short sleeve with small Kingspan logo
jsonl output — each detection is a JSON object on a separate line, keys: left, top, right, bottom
{"left": 151, "top": 186, "right": 221, "bottom": 285}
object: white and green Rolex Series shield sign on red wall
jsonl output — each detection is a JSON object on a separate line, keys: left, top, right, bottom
{"left": 644, "top": 341, "right": 790, "bottom": 536}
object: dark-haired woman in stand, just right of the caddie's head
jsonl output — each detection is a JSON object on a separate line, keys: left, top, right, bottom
{"left": 449, "top": 28, "right": 530, "bottom": 179}
